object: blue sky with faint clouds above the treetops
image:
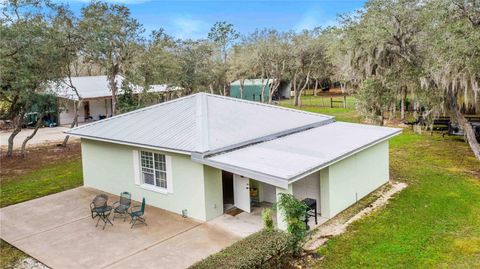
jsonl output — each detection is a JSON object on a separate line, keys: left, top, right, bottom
{"left": 60, "top": 0, "right": 365, "bottom": 39}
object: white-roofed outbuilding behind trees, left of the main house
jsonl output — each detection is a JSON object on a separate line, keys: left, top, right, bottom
{"left": 48, "top": 75, "right": 180, "bottom": 124}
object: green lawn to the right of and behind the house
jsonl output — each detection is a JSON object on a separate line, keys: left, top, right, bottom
{"left": 278, "top": 96, "right": 480, "bottom": 268}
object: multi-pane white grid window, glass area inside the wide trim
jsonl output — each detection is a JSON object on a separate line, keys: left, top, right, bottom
{"left": 140, "top": 151, "right": 167, "bottom": 189}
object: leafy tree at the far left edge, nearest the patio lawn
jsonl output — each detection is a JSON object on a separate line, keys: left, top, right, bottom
{"left": 0, "top": 0, "right": 64, "bottom": 157}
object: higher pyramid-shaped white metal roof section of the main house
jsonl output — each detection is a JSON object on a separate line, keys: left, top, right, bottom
{"left": 66, "top": 93, "right": 332, "bottom": 154}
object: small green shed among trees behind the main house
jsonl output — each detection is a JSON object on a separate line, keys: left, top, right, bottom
{"left": 230, "top": 79, "right": 290, "bottom": 102}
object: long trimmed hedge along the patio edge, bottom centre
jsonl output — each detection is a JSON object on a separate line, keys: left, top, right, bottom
{"left": 190, "top": 230, "right": 291, "bottom": 269}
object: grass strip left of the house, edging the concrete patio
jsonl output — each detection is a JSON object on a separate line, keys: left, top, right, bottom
{"left": 0, "top": 158, "right": 83, "bottom": 268}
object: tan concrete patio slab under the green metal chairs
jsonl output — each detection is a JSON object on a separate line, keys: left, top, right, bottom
{"left": 0, "top": 187, "right": 241, "bottom": 269}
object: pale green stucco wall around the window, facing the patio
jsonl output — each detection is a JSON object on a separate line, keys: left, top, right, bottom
{"left": 82, "top": 139, "right": 223, "bottom": 220}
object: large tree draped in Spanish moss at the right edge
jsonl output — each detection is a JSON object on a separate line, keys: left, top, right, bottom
{"left": 338, "top": 0, "right": 480, "bottom": 159}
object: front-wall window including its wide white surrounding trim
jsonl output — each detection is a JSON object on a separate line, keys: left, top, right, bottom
{"left": 137, "top": 150, "right": 173, "bottom": 193}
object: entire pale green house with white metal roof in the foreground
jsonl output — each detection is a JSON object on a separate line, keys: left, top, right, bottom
{"left": 66, "top": 93, "right": 401, "bottom": 228}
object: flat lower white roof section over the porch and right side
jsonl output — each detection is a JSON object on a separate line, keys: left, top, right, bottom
{"left": 199, "top": 122, "right": 401, "bottom": 188}
